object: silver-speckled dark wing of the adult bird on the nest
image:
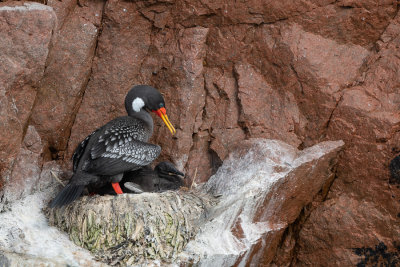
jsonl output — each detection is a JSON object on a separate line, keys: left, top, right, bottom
{"left": 84, "top": 125, "right": 161, "bottom": 175}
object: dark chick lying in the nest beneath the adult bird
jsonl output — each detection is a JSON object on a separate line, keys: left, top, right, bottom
{"left": 88, "top": 161, "right": 185, "bottom": 195}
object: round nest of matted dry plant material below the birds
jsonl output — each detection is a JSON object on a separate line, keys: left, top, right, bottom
{"left": 47, "top": 190, "right": 216, "bottom": 265}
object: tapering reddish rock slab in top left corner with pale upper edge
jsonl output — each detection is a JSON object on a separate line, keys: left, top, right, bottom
{"left": 0, "top": 2, "right": 56, "bottom": 184}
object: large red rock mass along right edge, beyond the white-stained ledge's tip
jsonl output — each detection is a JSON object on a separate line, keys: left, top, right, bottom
{"left": 288, "top": 11, "right": 400, "bottom": 266}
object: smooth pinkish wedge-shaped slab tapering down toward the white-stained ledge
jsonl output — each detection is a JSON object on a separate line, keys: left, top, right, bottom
{"left": 282, "top": 25, "right": 369, "bottom": 146}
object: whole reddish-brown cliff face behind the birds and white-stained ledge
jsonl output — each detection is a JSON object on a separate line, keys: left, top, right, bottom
{"left": 0, "top": 0, "right": 400, "bottom": 266}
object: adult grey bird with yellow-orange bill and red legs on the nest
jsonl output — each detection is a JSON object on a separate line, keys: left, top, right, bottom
{"left": 50, "top": 85, "right": 176, "bottom": 208}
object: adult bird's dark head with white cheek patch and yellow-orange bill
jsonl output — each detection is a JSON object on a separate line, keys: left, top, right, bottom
{"left": 125, "top": 85, "right": 176, "bottom": 134}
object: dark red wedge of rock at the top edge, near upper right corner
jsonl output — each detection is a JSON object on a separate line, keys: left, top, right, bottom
{"left": 291, "top": 0, "right": 396, "bottom": 48}
